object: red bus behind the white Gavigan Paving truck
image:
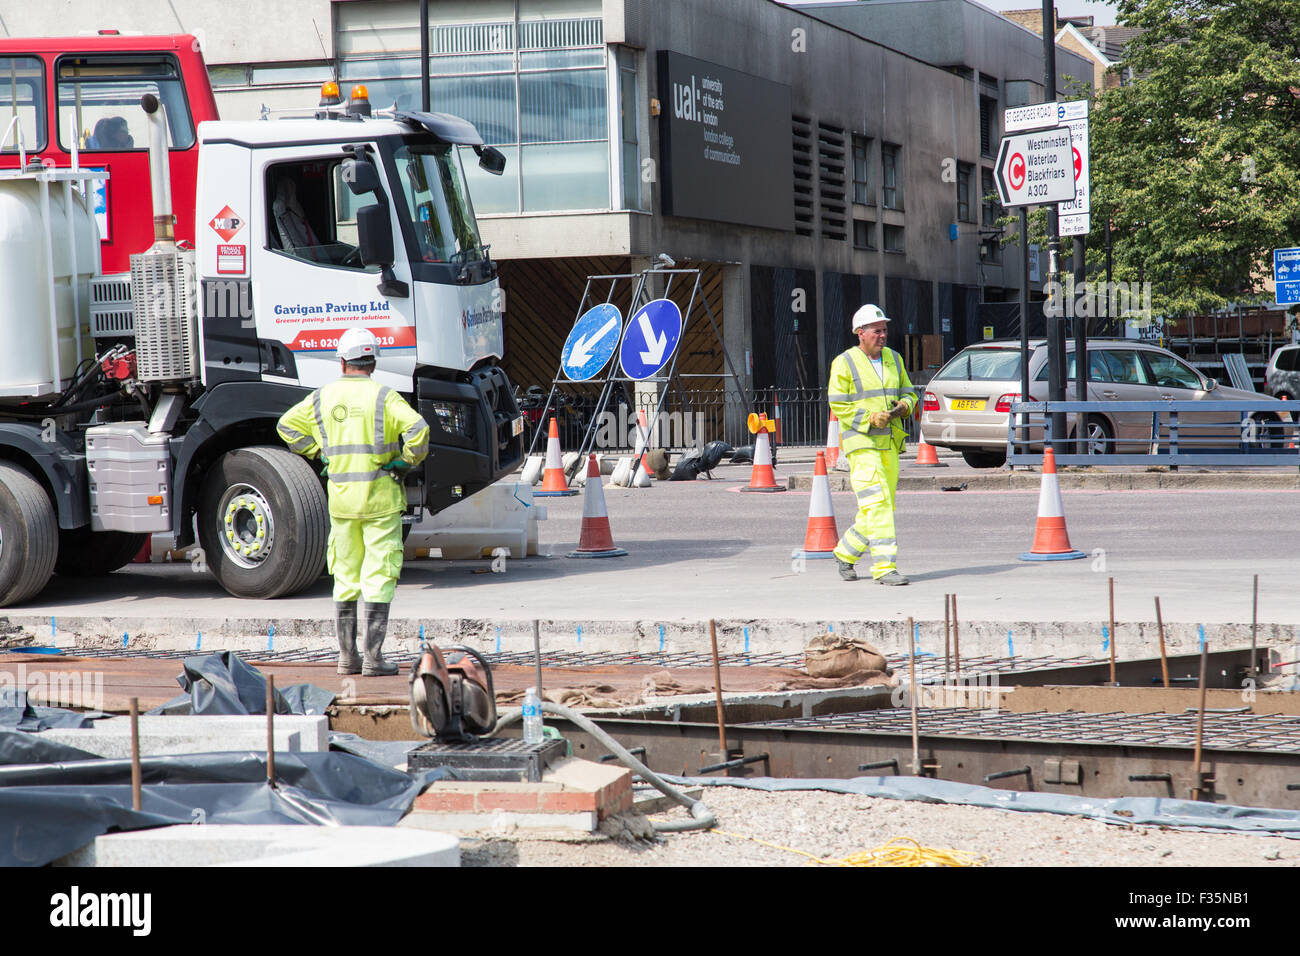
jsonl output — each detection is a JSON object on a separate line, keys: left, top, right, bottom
{"left": 0, "top": 33, "right": 217, "bottom": 273}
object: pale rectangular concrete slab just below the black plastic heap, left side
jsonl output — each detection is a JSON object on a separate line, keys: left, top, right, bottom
{"left": 40, "top": 715, "right": 329, "bottom": 758}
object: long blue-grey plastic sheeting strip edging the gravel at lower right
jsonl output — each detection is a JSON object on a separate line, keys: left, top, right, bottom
{"left": 662, "top": 774, "right": 1300, "bottom": 839}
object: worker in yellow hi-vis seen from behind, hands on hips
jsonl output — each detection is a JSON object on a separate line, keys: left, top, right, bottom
{"left": 276, "top": 329, "right": 429, "bottom": 676}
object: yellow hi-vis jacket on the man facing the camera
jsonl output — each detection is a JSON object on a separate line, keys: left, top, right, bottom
{"left": 827, "top": 346, "right": 917, "bottom": 454}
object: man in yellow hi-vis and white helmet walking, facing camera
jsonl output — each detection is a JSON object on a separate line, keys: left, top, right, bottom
{"left": 827, "top": 306, "right": 917, "bottom": 584}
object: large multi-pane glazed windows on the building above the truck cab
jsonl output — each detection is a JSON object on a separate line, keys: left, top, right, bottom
{"left": 335, "top": 0, "right": 613, "bottom": 213}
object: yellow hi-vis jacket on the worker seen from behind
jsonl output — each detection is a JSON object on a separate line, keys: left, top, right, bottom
{"left": 276, "top": 375, "right": 429, "bottom": 518}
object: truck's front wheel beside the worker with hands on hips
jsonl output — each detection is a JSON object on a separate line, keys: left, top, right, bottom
{"left": 199, "top": 446, "right": 329, "bottom": 598}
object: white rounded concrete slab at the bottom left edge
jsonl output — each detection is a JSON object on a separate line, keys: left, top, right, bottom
{"left": 55, "top": 825, "right": 460, "bottom": 866}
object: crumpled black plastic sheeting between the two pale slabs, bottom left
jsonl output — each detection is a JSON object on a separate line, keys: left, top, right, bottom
{"left": 0, "top": 749, "right": 445, "bottom": 866}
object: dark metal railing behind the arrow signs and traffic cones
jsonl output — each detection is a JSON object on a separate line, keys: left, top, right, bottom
{"left": 525, "top": 386, "right": 919, "bottom": 454}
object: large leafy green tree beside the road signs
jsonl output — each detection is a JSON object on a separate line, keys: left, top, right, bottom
{"left": 1088, "top": 0, "right": 1300, "bottom": 315}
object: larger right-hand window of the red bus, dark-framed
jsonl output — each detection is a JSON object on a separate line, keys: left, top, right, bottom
{"left": 57, "top": 56, "right": 194, "bottom": 152}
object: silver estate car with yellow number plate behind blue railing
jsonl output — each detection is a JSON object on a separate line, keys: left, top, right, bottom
{"left": 920, "top": 339, "right": 1290, "bottom": 468}
